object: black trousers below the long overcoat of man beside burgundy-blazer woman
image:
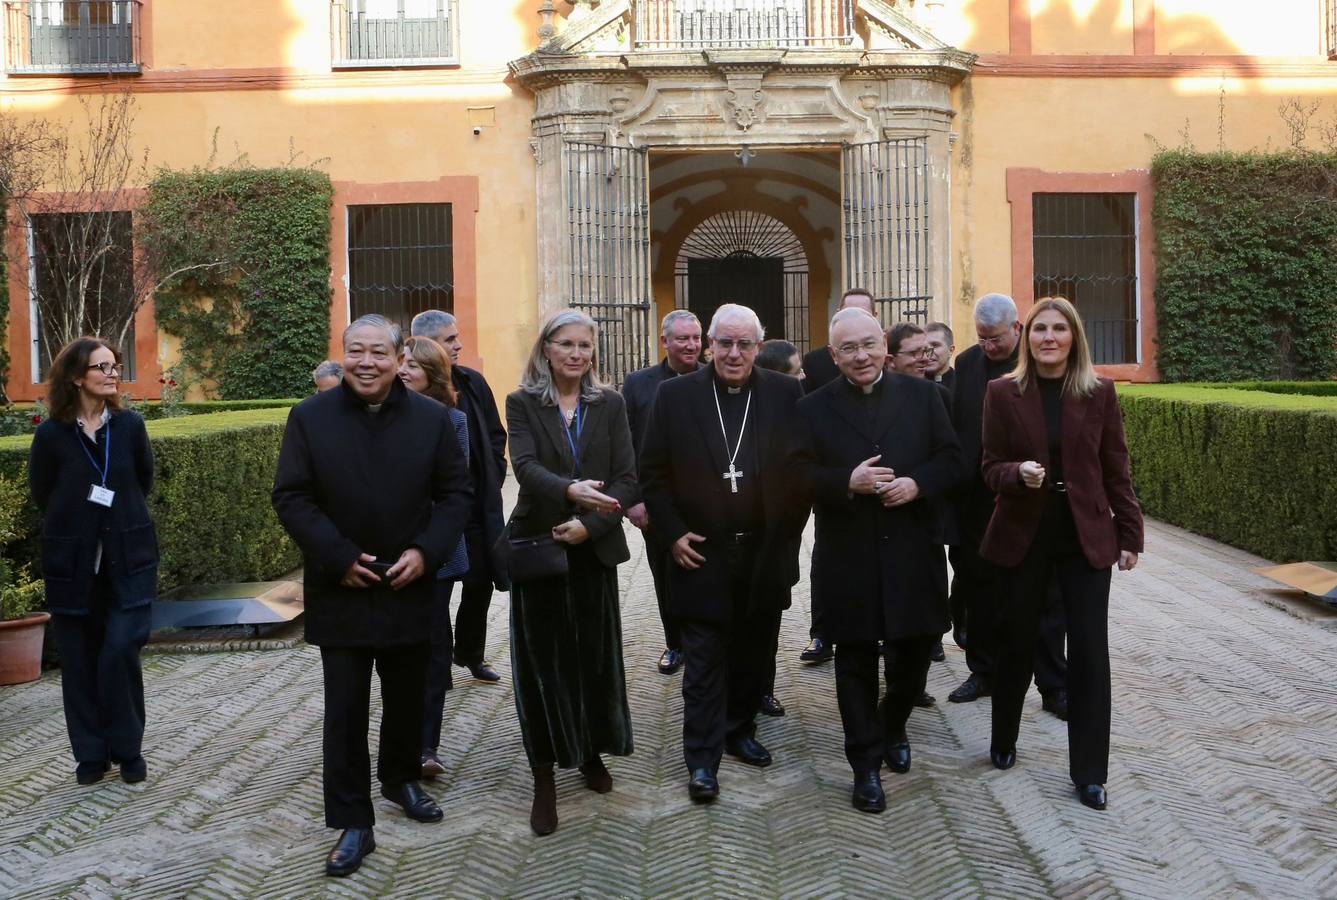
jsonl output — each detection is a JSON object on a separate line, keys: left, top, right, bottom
{"left": 836, "top": 637, "right": 937, "bottom": 777}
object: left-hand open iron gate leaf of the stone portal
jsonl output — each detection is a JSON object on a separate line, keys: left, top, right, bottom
{"left": 564, "top": 143, "right": 652, "bottom": 386}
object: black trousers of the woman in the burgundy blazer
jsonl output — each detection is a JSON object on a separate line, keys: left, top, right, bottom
{"left": 992, "top": 505, "right": 1111, "bottom": 785}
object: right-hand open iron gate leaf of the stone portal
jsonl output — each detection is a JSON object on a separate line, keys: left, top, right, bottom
{"left": 842, "top": 138, "right": 933, "bottom": 326}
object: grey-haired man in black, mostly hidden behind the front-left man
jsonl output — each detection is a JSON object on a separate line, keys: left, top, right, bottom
{"left": 409, "top": 309, "right": 511, "bottom": 690}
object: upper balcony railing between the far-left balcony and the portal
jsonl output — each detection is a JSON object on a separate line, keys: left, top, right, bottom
{"left": 330, "top": 0, "right": 460, "bottom": 68}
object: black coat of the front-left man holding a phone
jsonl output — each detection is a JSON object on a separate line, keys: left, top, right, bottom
{"left": 273, "top": 378, "right": 473, "bottom": 647}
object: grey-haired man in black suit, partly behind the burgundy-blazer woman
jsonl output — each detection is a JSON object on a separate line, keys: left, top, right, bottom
{"left": 948, "top": 294, "right": 1067, "bottom": 718}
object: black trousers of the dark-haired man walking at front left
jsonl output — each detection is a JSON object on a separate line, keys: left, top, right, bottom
{"left": 321, "top": 643, "right": 431, "bottom": 828}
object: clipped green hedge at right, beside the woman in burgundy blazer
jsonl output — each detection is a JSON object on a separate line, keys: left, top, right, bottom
{"left": 1119, "top": 385, "right": 1337, "bottom": 562}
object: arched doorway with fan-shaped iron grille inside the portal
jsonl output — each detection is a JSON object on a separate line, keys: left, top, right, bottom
{"left": 674, "top": 210, "right": 810, "bottom": 353}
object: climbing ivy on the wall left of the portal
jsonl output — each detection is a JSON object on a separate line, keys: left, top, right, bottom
{"left": 136, "top": 166, "right": 334, "bottom": 400}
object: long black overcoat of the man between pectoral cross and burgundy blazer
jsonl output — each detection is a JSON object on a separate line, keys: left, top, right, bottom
{"left": 797, "top": 372, "right": 961, "bottom": 643}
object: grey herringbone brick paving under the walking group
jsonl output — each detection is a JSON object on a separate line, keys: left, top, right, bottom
{"left": 0, "top": 523, "right": 1337, "bottom": 899}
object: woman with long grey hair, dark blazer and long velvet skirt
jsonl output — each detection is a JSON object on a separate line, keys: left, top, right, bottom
{"left": 505, "top": 309, "right": 639, "bottom": 834}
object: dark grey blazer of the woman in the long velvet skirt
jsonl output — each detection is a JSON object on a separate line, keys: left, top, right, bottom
{"left": 505, "top": 388, "right": 640, "bottom": 566}
